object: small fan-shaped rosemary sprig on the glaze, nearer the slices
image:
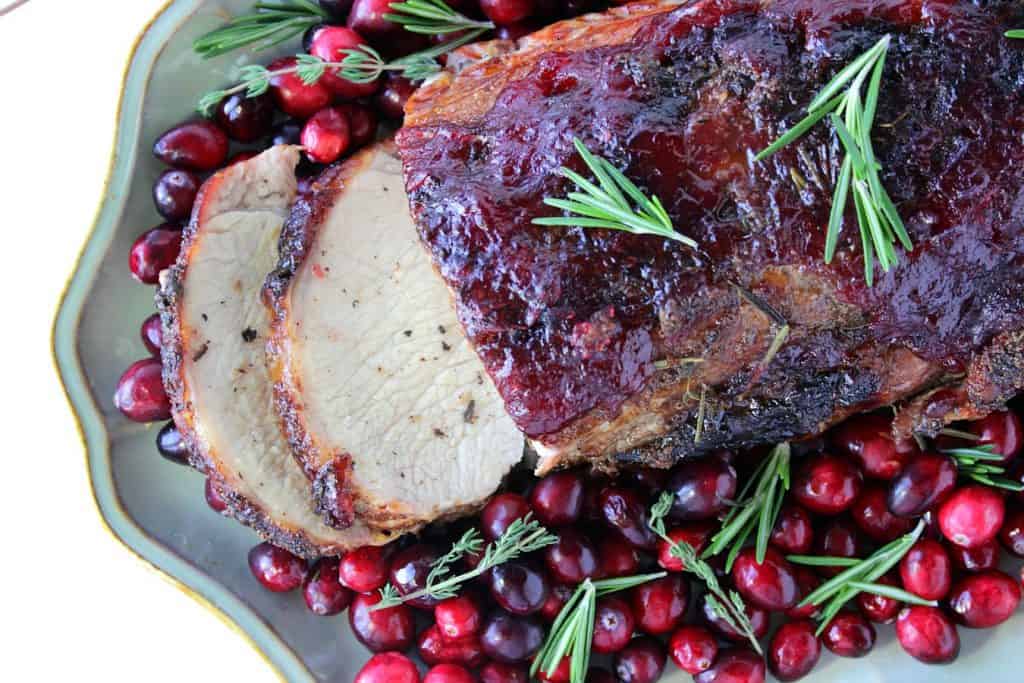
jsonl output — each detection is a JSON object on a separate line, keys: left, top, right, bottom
{"left": 534, "top": 138, "right": 697, "bottom": 248}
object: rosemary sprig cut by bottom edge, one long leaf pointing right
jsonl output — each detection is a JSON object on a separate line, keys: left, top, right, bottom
{"left": 529, "top": 571, "right": 668, "bottom": 683}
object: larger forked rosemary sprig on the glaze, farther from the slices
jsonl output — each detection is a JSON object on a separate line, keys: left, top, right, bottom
{"left": 755, "top": 36, "right": 913, "bottom": 287}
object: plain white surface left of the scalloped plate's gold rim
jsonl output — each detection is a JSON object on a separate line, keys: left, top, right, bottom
{"left": 0, "top": 0, "right": 276, "bottom": 683}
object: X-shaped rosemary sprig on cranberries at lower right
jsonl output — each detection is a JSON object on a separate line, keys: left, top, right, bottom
{"left": 786, "top": 520, "right": 936, "bottom": 635}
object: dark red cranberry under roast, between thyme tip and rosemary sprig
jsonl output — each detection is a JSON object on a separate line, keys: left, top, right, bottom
{"left": 667, "top": 458, "right": 736, "bottom": 520}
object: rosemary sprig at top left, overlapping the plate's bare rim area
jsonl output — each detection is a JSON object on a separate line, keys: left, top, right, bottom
{"left": 193, "top": 0, "right": 328, "bottom": 59}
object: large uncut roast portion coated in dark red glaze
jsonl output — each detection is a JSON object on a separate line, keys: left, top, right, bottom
{"left": 397, "top": 0, "right": 1024, "bottom": 472}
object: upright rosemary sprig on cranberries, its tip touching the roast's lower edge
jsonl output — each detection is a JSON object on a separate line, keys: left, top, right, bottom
{"left": 701, "top": 442, "right": 790, "bottom": 571}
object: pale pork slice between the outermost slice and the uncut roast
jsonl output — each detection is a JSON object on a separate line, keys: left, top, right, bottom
{"left": 265, "top": 142, "right": 523, "bottom": 531}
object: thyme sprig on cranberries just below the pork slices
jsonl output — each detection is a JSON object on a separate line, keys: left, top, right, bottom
{"left": 372, "top": 514, "right": 558, "bottom": 609}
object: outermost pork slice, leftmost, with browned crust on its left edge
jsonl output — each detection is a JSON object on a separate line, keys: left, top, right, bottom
{"left": 157, "top": 146, "right": 388, "bottom": 557}
